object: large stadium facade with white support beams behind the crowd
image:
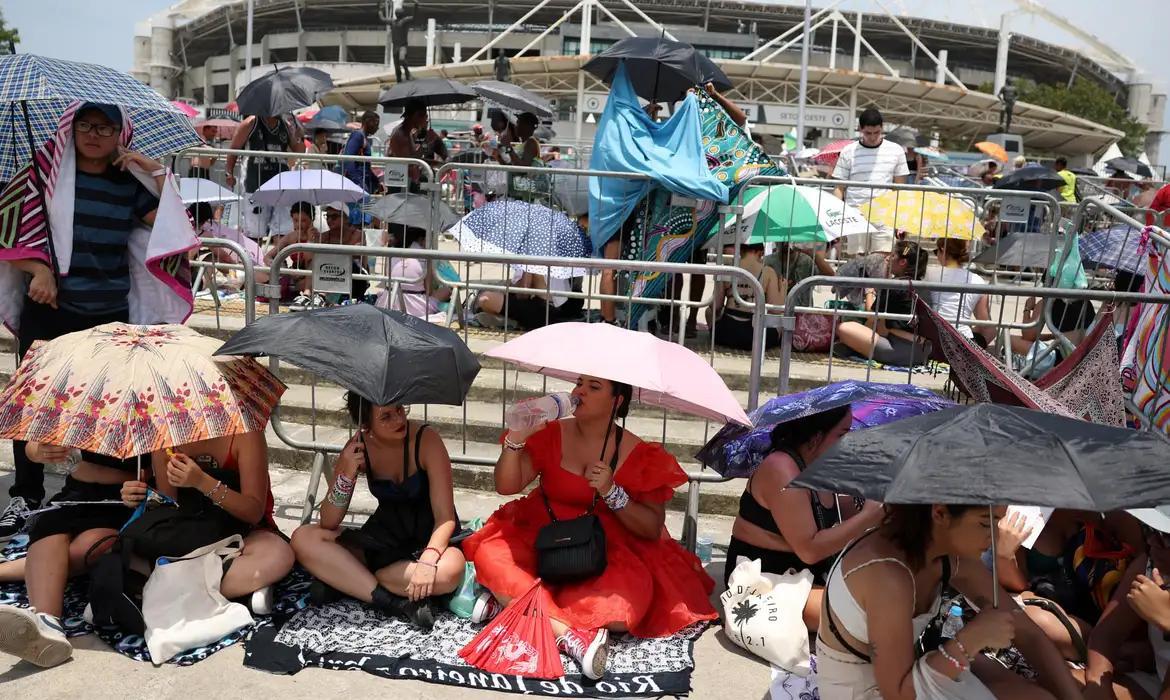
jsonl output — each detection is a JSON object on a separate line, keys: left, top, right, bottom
{"left": 132, "top": 0, "right": 1170, "bottom": 164}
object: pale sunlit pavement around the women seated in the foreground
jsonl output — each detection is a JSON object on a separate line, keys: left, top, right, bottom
{"left": 0, "top": 463, "right": 770, "bottom": 700}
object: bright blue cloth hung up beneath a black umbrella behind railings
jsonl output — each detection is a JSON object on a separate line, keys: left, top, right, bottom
{"left": 589, "top": 63, "right": 728, "bottom": 255}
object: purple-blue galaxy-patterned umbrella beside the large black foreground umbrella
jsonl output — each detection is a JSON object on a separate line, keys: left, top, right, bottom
{"left": 695, "top": 380, "right": 955, "bottom": 478}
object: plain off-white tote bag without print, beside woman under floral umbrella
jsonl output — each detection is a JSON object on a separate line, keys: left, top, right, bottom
{"left": 143, "top": 535, "right": 253, "bottom": 665}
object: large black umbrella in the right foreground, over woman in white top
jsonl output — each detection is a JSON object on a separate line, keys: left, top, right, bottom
{"left": 792, "top": 404, "right": 1170, "bottom": 513}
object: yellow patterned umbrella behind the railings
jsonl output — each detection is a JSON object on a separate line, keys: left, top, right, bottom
{"left": 861, "top": 190, "right": 984, "bottom": 240}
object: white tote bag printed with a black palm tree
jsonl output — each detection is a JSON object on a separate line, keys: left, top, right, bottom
{"left": 720, "top": 557, "right": 812, "bottom": 677}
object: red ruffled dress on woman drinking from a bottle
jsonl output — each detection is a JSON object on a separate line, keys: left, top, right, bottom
{"left": 463, "top": 423, "right": 718, "bottom": 637}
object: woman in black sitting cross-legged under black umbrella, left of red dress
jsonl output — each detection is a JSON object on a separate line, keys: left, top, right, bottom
{"left": 293, "top": 391, "right": 464, "bottom": 631}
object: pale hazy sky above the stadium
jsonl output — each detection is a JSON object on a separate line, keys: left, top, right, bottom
{"left": 0, "top": 0, "right": 1170, "bottom": 90}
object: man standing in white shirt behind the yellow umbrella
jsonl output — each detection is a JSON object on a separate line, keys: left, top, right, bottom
{"left": 833, "top": 108, "right": 910, "bottom": 254}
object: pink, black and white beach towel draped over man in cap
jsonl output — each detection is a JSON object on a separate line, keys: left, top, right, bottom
{"left": 0, "top": 102, "right": 199, "bottom": 332}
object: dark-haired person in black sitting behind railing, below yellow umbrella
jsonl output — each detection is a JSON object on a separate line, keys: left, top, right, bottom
{"left": 837, "top": 241, "right": 930, "bottom": 366}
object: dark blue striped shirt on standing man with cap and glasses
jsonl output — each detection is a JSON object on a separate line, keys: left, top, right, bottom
{"left": 57, "top": 166, "right": 158, "bottom": 316}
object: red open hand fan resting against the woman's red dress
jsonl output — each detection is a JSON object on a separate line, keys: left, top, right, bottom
{"left": 459, "top": 578, "right": 565, "bottom": 679}
